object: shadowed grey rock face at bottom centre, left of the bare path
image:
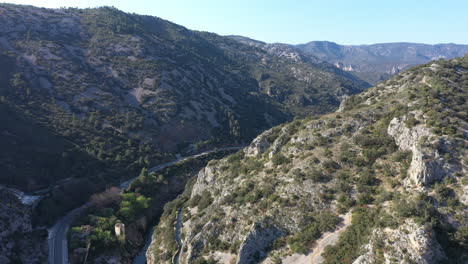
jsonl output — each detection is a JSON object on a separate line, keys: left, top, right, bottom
{"left": 236, "top": 222, "right": 283, "bottom": 264}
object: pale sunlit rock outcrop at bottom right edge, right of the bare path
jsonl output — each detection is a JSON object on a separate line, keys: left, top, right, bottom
{"left": 353, "top": 219, "right": 446, "bottom": 264}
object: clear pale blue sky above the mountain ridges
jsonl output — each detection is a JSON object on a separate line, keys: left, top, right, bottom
{"left": 0, "top": 0, "right": 468, "bottom": 44}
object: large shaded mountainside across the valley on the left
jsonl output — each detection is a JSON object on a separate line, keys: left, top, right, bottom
{"left": 0, "top": 4, "right": 368, "bottom": 193}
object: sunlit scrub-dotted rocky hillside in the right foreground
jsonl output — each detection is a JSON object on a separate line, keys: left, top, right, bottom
{"left": 147, "top": 57, "right": 468, "bottom": 264}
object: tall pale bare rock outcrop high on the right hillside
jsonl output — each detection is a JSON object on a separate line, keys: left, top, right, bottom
{"left": 388, "top": 113, "right": 447, "bottom": 186}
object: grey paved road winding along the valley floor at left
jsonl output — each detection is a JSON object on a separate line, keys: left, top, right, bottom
{"left": 48, "top": 147, "right": 243, "bottom": 264}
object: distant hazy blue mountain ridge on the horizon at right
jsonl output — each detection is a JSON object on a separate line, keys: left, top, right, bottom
{"left": 296, "top": 41, "right": 468, "bottom": 84}
